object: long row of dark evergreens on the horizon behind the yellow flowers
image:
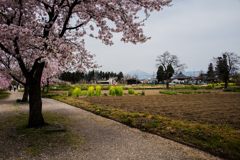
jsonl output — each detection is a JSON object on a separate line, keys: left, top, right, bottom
{"left": 59, "top": 70, "right": 123, "bottom": 83}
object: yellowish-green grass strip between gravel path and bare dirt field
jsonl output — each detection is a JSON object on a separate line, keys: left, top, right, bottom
{"left": 49, "top": 96, "right": 240, "bottom": 159}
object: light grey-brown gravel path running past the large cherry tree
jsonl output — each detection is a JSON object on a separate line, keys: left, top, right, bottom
{"left": 0, "top": 93, "right": 221, "bottom": 160}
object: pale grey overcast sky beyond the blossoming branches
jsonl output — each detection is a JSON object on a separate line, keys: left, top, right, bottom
{"left": 86, "top": 0, "right": 240, "bottom": 73}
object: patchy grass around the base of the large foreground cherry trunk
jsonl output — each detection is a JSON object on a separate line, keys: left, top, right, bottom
{"left": 0, "top": 111, "right": 83, "bottom": 159}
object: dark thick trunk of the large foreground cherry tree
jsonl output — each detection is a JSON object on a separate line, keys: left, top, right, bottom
{"left": 28, "top": 62, "right": 45, "bottom": 128}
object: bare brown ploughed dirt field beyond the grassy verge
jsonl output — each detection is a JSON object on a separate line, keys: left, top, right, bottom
{"left": 86, "top": 93, "right": 240, "bottom": 129}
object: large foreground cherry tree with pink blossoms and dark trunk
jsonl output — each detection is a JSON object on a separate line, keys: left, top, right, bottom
{"left": 0, "top": 0, "right": 171, "bottom": 127}
